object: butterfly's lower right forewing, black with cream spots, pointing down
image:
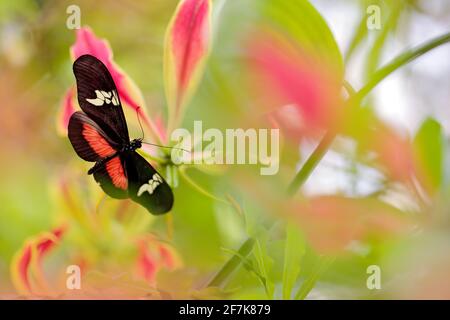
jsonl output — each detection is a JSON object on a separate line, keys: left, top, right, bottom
{"left": 124, "top": 152, "right": 173, "bottom": 215}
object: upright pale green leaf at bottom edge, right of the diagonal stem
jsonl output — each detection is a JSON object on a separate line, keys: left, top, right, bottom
{"left": 283, "top": 224, "right": 305, "bottom": 300}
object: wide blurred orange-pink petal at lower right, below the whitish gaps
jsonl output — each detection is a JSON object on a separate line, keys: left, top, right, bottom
{"left": 295, "top": 196, "right": 414, "bottom": 254}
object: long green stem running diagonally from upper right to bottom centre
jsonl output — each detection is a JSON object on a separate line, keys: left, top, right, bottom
{"left": 208, "top": 32, "right": 450, "bottom": 290}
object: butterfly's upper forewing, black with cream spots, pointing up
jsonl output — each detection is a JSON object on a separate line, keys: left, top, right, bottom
{"left": 73, "top": 55, "right": 130, "bottom": 143}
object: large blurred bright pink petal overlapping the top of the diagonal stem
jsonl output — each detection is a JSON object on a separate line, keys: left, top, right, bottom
{"left": 248, "top": 31, "right": 342, "bottom": 138}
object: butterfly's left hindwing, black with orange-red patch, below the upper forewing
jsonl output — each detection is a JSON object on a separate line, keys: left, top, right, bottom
{"left": 68, "top": 111, "right": 119, "bottom": 162}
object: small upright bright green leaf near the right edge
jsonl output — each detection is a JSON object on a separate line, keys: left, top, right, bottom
{"left": 414, "top": 118, "right": 445, "bottom": 191}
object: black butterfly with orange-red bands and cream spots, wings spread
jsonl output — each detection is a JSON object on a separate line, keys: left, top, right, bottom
{"left": 68, "top": 55, "right": 174, "bottom": 215}
